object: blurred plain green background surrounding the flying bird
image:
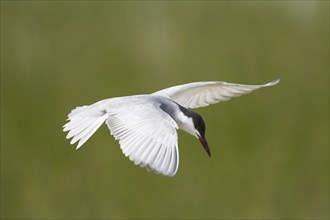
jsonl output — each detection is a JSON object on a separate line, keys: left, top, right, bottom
{"left": 1, "top": 1, "right": 329, "bottom": 219}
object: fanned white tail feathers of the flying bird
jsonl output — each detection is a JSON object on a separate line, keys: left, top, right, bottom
{"left": 63, "top": 105, "right": 108, "bottom": 149}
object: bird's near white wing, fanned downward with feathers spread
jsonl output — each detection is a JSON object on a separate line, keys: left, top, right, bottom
{"left": 106, "top": 99, "right": 179, "bottom": 176}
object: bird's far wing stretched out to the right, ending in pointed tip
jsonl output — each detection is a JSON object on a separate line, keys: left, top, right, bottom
{"left": 153, "top": 79, "right": 280, "bottom": 108}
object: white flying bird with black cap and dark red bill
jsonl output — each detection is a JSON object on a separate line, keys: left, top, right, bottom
{"left": 63, "top": 79, "right": 280, "bottom": 177}
